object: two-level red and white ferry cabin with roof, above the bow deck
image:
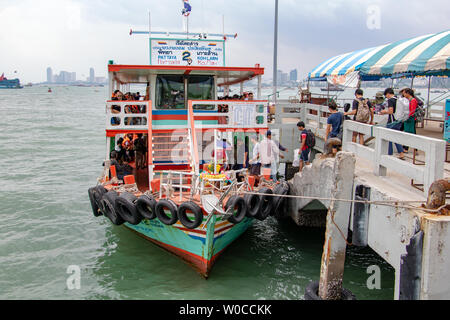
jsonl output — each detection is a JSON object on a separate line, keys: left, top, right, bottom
{"left": 106, "top": 64, "right": 268, "bottom": 190}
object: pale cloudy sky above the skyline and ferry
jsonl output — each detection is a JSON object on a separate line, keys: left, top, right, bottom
{"left": 0, "top": 0, "right": 450, "bottom": 83}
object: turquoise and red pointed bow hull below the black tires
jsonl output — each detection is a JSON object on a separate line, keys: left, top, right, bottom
{"left": 124, "top": 216, "right": 253, "bottom": 278}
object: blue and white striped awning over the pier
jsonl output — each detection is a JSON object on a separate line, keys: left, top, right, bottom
{"left": 308, "top": 30, "right": 450, "bottom": 78}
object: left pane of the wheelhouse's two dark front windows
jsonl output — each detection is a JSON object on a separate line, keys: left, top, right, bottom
{"left": 155, "top": 75, "right": 185, "bottom": 109}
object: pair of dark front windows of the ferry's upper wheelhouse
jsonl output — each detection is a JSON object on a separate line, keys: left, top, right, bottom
{"left": 155, "top": 75, "right": 215, "bottom": 110}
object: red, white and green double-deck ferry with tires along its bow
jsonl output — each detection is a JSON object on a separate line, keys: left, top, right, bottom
{"left": 88, "top": 39, "right": 289, "bottom": 278}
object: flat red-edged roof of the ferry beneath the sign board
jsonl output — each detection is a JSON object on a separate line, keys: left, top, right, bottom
{"left": 108, "top": 64, "right": 264, "bottom": 86}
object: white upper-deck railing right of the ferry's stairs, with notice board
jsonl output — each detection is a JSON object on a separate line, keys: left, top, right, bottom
{"left": 189, "top": 100, "right": 267, "bottom": 128}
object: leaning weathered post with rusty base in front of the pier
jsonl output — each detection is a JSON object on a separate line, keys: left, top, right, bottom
{"left": 319, "top": 152, "right": 356, "bottom": 300}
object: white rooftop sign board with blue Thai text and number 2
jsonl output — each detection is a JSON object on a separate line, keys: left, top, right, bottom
{"left": 150, "top": 39, "right": 225, "bottom": 67}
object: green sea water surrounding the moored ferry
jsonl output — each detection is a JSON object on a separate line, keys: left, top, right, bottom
{"left": 0, "top": 87, "right": 394, "bottom": 300}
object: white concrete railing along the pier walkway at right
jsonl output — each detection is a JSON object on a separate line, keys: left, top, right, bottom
{"left": 342, "top": 120, "right": 445, "bottom": 194}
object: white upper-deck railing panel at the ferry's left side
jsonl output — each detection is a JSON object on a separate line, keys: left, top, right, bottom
{"left": 106, "top": 101, "right": 151, "bottom": 130}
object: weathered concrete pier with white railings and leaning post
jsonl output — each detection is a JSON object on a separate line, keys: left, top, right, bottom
{"left": 276, "top": 100, "right": 450, "bottom": 300}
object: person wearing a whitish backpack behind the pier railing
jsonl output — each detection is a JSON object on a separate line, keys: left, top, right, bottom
{"left": 379, "top": 88, "right": 406, "bottom": 160}
